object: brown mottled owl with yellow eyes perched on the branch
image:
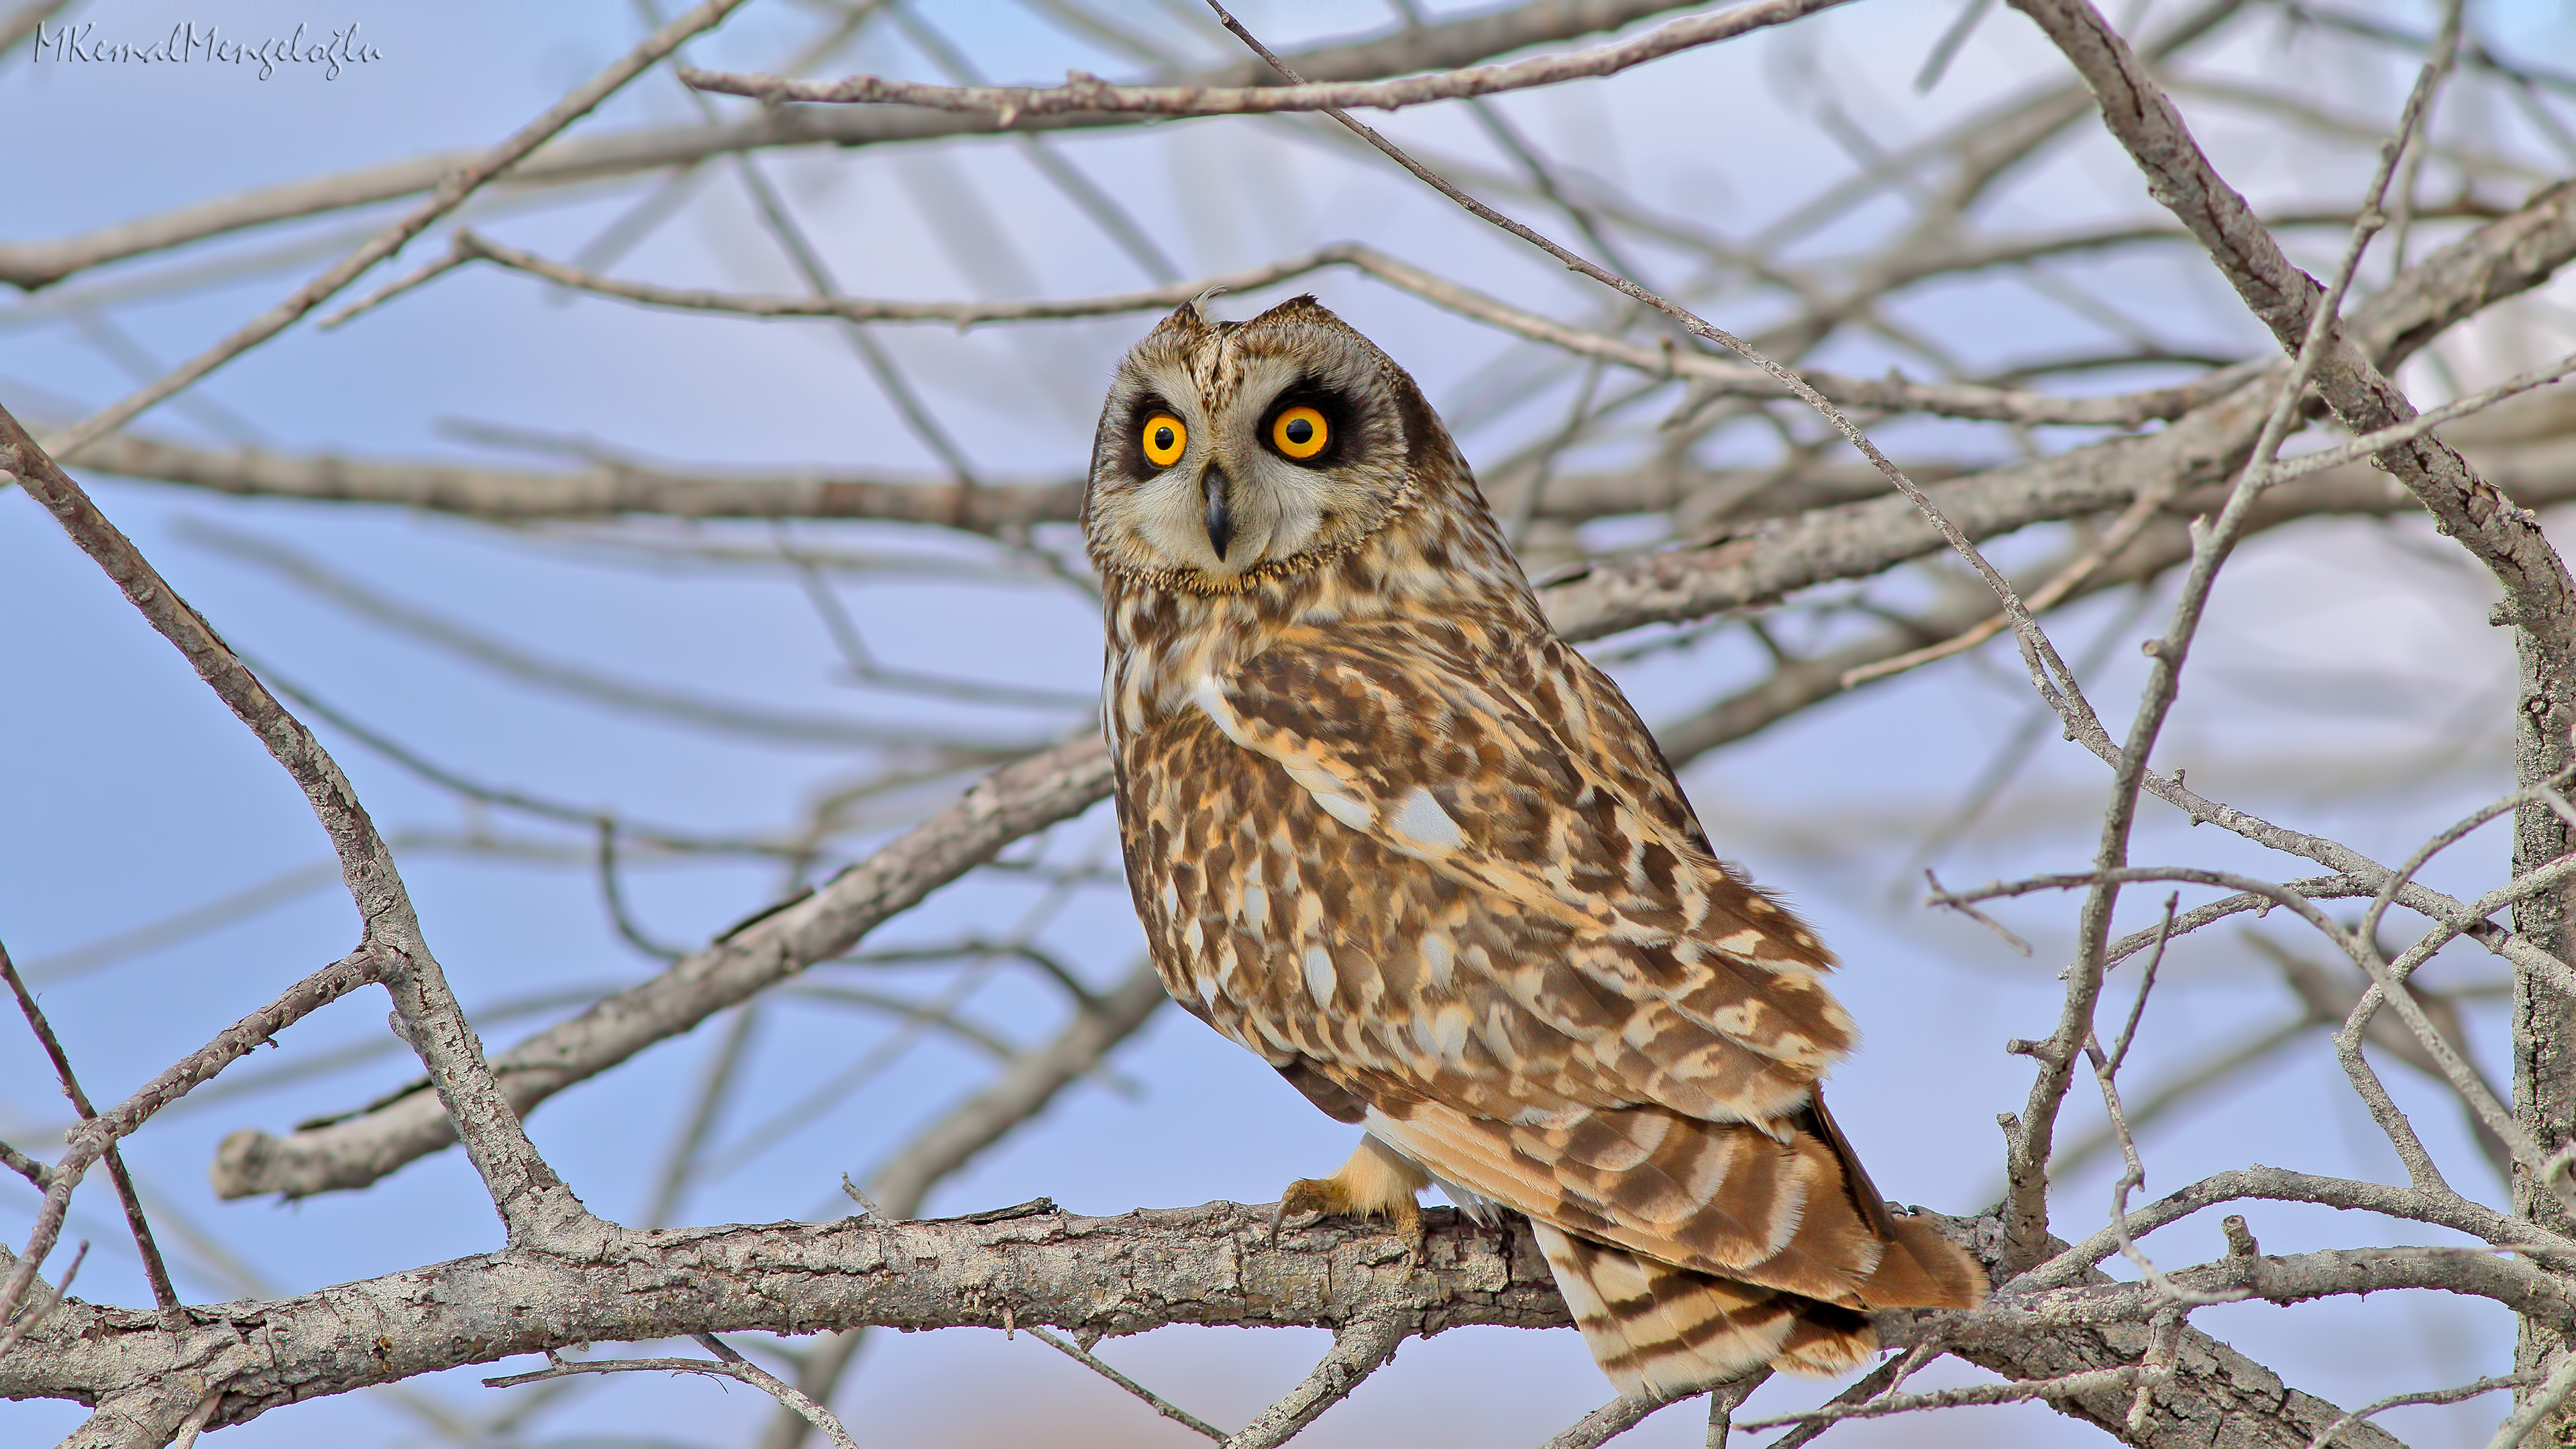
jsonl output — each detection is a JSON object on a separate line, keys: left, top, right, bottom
{"left": 1082, "top": 297, "right": 1986, "bottom": 1395}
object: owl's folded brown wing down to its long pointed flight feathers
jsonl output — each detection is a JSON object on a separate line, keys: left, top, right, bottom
{"left": 1185, "top": 613, "right": 1973, "bottom": 1307}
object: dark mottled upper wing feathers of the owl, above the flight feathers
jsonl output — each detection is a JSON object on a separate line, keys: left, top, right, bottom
{"left": 1193, "top": 613, "right": 1855, "bottom": 1122}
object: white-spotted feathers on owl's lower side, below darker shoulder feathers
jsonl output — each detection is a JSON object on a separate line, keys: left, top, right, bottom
{"left": 1118, "top": 714, "right": 1628, "bottom": 1116}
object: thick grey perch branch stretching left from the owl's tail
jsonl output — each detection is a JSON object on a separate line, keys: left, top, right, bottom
{"left": 0, "top": 1204, "right": 1571, "bottom": 1424}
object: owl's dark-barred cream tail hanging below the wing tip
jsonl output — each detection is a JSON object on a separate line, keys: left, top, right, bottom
{"left": 1530, "top": 1220, "right": 1878, "bottom": 1397}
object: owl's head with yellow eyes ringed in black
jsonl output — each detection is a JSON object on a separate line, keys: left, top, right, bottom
{"left": 1082, "top": 297, "right": 1481, "bottom": 590}
